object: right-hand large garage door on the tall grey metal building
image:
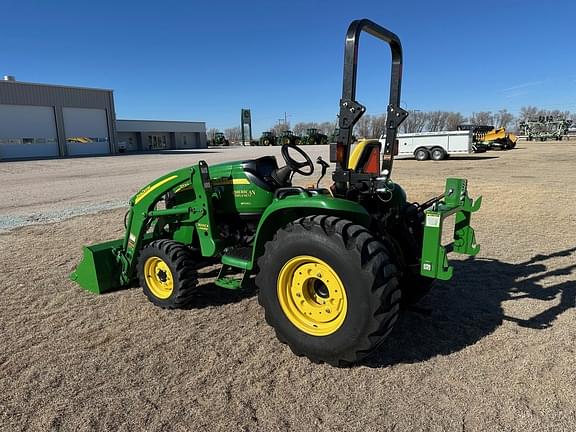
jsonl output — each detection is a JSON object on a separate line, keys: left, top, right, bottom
{"left": 63, "top": 108, "right": 110, "bottom": 156}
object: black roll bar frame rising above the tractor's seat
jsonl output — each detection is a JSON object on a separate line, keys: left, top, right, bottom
{"left": 333, "top": 19, "right": 408, "bottom": 187}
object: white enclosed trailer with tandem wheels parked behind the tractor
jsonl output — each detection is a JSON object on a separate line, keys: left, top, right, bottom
{"left": 380, "top": 131, "right": 474, "bottom": 161}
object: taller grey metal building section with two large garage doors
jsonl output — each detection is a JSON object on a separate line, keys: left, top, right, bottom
{"left": 0, "top": 76, "right": 116, "bottom": 159}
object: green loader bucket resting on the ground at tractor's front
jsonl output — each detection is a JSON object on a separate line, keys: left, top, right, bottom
{"left": 70, "top": 239, "right": 123, "bottom": 294}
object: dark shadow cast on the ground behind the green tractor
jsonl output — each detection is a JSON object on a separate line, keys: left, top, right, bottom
{"left": 363, "top": 247, "right": 576, "bottom": 368}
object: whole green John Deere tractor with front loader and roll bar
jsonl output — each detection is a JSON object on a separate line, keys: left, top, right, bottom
{"left": 71, "top": 20, "right": 481, "bottom": 365}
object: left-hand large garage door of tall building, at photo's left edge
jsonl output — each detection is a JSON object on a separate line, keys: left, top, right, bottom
{"left": 0, "top": 105, "right": 58, "bottom": 159}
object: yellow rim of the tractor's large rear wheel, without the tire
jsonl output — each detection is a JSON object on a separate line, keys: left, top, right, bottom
{"left": 277, "top": 255, "right": 348, "bottom": 336}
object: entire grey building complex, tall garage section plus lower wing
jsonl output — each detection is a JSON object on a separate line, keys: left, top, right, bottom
{"left": 0, "top": 76, "right": 206, "bottom": 160}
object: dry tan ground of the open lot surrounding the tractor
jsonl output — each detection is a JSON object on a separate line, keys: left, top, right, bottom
{"left": 0, "top": 142, "right": 576, "bottom": 431}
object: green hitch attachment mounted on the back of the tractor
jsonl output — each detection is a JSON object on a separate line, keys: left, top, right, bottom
{"left": 420, "top": 178, "right": 482, "bottom": 280}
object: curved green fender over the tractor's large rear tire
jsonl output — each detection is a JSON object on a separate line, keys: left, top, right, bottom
{"left": 249, "top": 191, "right": 370, "bottom": 270}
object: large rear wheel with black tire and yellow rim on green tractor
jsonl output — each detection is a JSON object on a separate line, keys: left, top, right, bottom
{"left": 256, "top": 216, "right": 401, "bottom": 366}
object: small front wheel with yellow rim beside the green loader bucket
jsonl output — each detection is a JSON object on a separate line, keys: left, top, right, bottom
{"left": 137, "top": 240, "right": 198, "bottom": 309}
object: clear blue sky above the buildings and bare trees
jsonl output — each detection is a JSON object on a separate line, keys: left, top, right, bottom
{"left": 0, "top": 0, "right": 576, "bottom": 134}
